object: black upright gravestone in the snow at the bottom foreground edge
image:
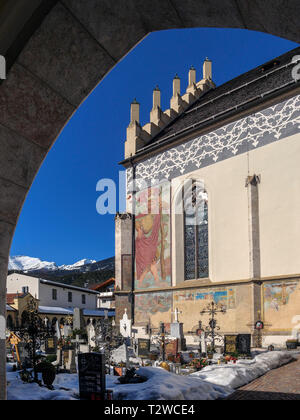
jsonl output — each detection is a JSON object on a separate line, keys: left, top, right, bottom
{"left": 78, "top": 353, "right": 106, "bottom": 400}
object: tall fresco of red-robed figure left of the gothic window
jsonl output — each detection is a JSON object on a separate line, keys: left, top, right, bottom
{"left": 135, "top": 183, "right": 171, "bottom": 290}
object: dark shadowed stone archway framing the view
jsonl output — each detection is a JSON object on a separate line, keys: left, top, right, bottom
{"left": 0, "top": 0, "right": 300, "bottom": 399}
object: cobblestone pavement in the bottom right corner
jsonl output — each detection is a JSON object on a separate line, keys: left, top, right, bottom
{"left": 227, "top": 356, "right": 300, "bottom": 400}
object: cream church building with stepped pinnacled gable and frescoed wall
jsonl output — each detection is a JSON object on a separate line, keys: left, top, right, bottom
{"left": 115, "top": 48, "right": 300, "bottom": 345}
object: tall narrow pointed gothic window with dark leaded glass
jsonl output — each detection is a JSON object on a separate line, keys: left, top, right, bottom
{"left": 183, "top": 180, "right": 209, "bottom": 280}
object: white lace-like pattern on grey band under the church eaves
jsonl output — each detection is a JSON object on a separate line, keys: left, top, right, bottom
{"left": 127, "top": 95, "right": 300, "bottom": 188}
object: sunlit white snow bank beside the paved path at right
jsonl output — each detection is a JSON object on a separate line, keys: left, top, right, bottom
{"left": 190, "top": 351, "right": 294, "bottom": 389}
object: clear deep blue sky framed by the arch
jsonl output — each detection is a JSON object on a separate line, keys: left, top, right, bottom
{"left": 11, "top": 29, "right": 298, "bottom": 264}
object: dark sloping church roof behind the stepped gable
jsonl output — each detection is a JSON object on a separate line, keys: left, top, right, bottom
{"left": 121, "top": 47, "right": 300, "bottom": 163}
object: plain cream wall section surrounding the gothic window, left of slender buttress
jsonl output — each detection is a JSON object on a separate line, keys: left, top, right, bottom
{"left": 172, "top": 154, "right": 250, "bottom": 285}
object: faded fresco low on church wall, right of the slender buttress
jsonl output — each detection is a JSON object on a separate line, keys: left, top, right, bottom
{"left": 264, "top": 281, "right": 298, "bottom": 311}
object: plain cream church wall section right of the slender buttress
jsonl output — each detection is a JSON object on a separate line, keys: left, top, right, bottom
{"left": 249, "top": 134, "right": 300, "bottom": 277}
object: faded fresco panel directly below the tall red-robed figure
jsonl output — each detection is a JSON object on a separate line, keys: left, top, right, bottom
{"left": 135, "top": 292, "right": 172, "bottom": 323}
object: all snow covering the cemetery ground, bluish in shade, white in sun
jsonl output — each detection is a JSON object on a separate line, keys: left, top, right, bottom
{"left": 7, "top": 351, "right": 293, "bottom": 400}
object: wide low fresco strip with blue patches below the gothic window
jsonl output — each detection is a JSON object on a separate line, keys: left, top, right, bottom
{"left": 174, "top": 288, "right": 236, "bottom": 309}
